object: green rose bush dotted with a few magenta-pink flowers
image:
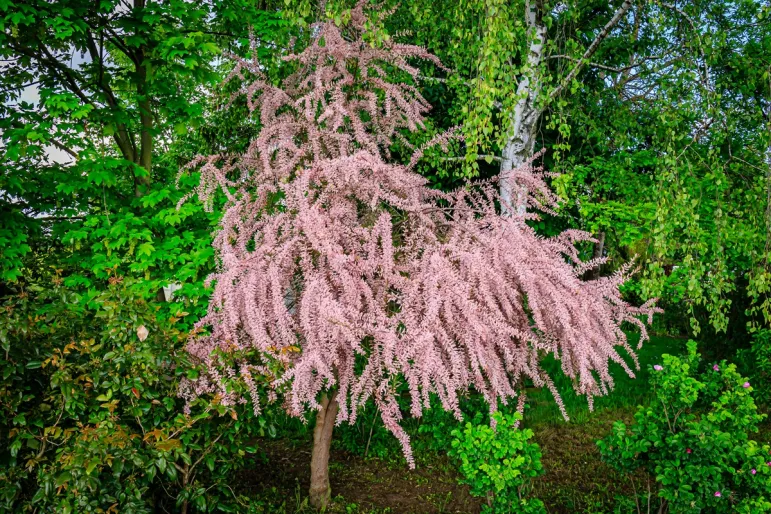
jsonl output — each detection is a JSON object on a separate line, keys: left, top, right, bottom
{"left": 597, "top": 341, "right": 771, "bottom": 514}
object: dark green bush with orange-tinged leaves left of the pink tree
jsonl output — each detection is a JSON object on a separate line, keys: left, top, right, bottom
{"left": 0, "top": 278, "right": 269, "bottom": 513}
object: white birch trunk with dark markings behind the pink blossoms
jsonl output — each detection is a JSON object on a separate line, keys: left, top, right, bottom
{"left": 500, "top": 1, "right": 546, "bottom": 214}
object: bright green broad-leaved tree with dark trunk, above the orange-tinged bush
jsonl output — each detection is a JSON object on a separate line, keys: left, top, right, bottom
{"left": 0, "top": 1, "right": 281, "bottom": 295}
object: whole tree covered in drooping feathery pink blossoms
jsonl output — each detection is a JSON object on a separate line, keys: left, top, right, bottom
{"left": 181, "top": 3, "right": 656, "bottom": 508}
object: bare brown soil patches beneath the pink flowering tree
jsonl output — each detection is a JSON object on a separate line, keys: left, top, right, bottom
{"left": 238, "top": 411, "right": 771, "bottom": 514}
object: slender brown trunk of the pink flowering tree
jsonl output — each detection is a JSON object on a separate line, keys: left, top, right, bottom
{"left": 309, "top": 392, "right": 338, "bottom": 509}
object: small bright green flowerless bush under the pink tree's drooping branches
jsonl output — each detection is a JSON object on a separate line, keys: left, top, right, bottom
{"left": 450, "top": 412, "right": 546, "bottom": 514}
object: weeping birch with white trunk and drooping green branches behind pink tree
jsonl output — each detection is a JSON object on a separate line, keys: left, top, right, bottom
{"left": 384, "top": 0, "right": 769, "bottom": 340}
